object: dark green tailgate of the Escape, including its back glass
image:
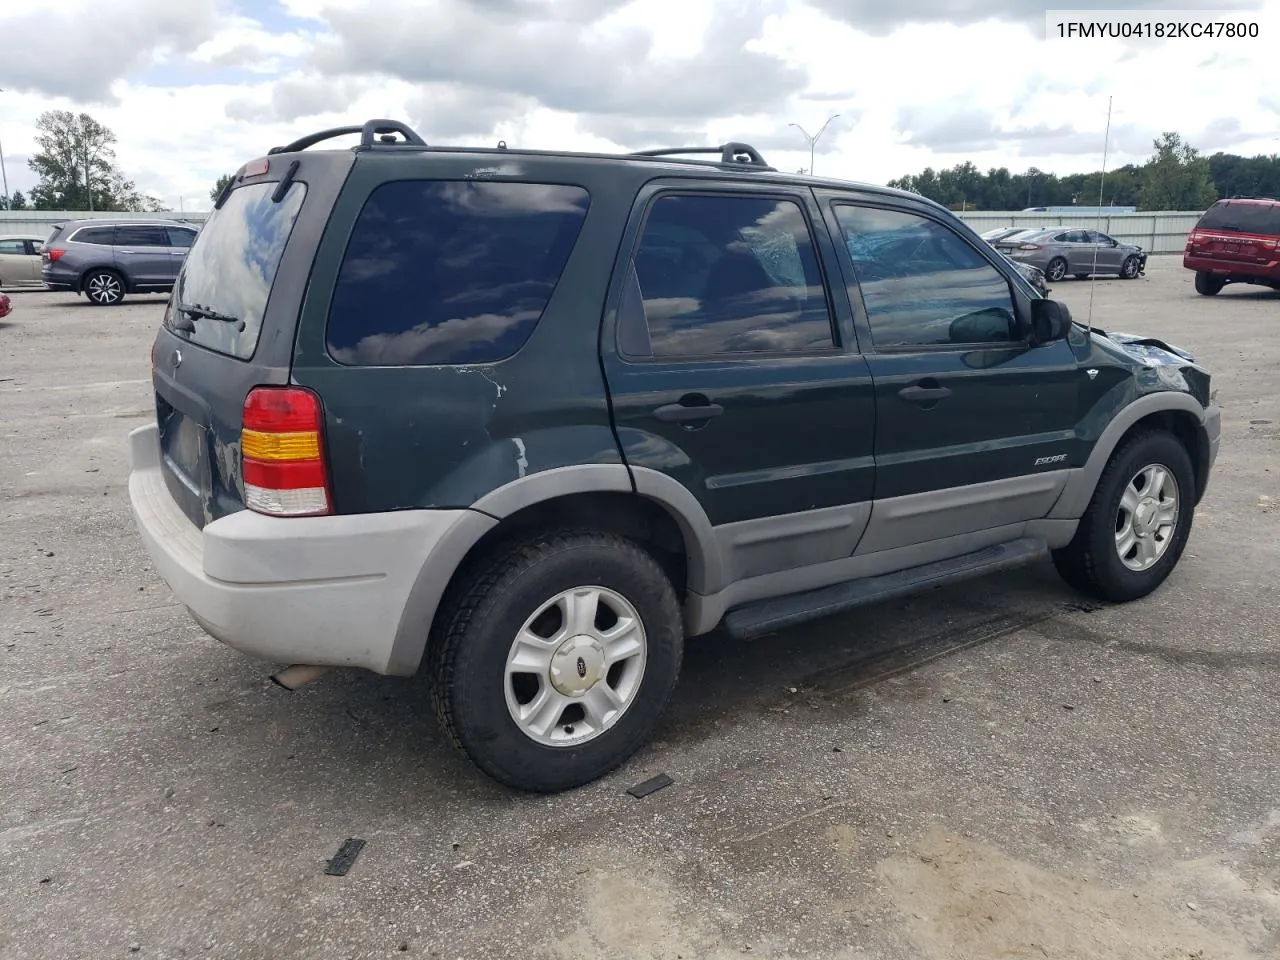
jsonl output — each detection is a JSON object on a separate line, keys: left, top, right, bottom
{"left": 152, "top": 151, "right": 355, "bottom": 527}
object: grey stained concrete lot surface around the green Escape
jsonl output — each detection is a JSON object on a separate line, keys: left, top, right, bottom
{"left": 0, "top": 259, "right": 1280, "bottom": 960}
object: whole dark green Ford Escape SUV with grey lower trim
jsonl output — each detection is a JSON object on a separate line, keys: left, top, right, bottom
{"left": 129, "top": 120, "right": 1221, "bottom": 791}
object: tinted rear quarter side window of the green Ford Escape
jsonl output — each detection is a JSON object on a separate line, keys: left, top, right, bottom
{"left": 327, "top": 180, "right": 588, "bottom": 366}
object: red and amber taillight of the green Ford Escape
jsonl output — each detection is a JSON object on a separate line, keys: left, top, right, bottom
{"left": 241, "top": 387, "right": 333, "bottom": 517}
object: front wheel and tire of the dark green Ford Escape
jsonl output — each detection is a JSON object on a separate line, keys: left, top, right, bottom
{"left": 1053, "top": 431, "right": 1196, "bottom": 603}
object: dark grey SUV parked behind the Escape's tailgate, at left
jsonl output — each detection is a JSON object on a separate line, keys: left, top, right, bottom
{"left": 41, "top": 219, "right": 197, "bottom": 306}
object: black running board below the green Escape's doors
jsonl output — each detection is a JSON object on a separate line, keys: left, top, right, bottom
{"left": 724, "top": 536, "right": 1047, "bottom": 640}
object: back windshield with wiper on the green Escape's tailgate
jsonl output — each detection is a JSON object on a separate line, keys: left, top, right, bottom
{"left": 165, "top": 180, "right": 306, "bottom": 360}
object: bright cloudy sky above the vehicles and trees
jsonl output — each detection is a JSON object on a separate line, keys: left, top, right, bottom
{"left": 0, "top": 0, "right": 1280, "bottom": 210}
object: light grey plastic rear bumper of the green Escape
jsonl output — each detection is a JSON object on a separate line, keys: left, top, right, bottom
{"left": 129, "top": 424, "right": 479, "bottom": 673}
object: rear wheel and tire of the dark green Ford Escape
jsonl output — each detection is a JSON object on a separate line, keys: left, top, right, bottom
{"left": 433, "top": 530, "right": 684, "bottom": 792}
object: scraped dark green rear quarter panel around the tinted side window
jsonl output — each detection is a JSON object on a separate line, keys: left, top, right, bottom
{"left": 285, "top": 152, "right": 645, "bottom": 513}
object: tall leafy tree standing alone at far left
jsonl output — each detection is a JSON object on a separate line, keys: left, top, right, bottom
{"left": 27, "top": 110, "right": 160, "bottom": 210}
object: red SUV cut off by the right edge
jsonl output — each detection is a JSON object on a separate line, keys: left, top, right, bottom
{"left": 1183, "top": 197, "right": 1280, "bottom": 297}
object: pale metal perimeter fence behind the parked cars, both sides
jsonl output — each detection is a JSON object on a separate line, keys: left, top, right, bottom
{"left": 0, "top": 210, "right": 1201, "bottom": 253}
